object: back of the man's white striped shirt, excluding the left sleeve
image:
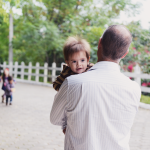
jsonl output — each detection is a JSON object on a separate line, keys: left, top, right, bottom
{"left": 61, "top": 61, "right": 140, "bottom": 150}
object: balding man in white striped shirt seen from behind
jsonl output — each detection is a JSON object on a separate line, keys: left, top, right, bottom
{"left": 50, "top": 25, "right": 141, "bottom": 150}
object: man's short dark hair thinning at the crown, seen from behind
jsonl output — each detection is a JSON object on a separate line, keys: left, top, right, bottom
{"left": 101, "top": 25, "right": 132, "bottom": 60}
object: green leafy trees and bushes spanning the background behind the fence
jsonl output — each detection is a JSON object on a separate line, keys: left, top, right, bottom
{"left": 0, "top": 0, "right": 149, "bottom": 69}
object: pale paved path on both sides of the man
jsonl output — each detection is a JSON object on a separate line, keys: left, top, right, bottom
{"left": 0, "top": 83, "right": 150, "bottom": 150}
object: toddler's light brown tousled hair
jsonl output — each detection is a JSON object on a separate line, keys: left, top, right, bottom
{"left": 63, "top": 36, "right": 90, "bottom": 60}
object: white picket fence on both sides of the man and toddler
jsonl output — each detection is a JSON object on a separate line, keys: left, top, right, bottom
{"left": 1, "top": 62, "right": 150, "bottom": 93}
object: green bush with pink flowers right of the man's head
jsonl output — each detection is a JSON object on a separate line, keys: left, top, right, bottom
{"left": 122, "top": 22, "right": 150, "bottom": 73}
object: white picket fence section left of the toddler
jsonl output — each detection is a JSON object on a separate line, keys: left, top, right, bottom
{"left": 0, "top": 62, "right": 64, "bottom": 83}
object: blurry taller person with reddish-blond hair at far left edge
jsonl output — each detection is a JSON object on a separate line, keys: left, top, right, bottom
{"left": 2, "top": 68, "right": 9, "bottom": 103}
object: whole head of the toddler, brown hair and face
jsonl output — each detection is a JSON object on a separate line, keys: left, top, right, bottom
{"left": 63, "top": 37, "right": 90, "bottom": 73}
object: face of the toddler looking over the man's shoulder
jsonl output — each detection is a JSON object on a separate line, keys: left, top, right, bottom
{"left": 66, "top": 51, "right": 89, "bottom": 74}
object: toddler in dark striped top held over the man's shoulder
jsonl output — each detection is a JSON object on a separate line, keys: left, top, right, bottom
{"left": 53, "top": 37, "right": 94, "bottom": 134}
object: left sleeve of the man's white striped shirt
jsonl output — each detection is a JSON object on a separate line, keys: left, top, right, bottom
{"left": 50, "top": 79, "right": 68, "bottom": 128}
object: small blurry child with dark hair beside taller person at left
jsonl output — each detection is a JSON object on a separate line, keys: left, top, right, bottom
{"left": 5, "top": 76, "right": 14, "bottom": 105}
